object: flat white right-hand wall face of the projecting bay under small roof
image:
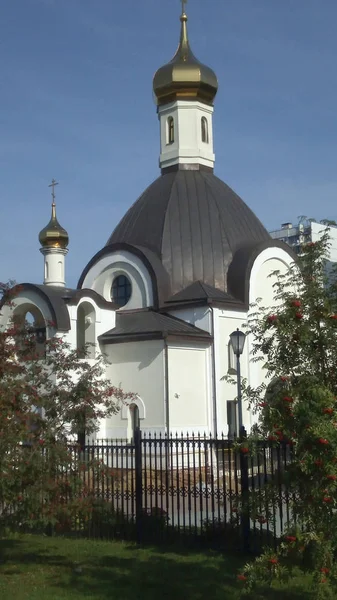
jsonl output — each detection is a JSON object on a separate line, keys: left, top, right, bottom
{"left": 168, "top": 343, "right": 212, "bottom": 435}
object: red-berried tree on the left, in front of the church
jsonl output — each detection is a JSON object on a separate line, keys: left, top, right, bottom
{"left": 0, "top": 286, "right": 135, "bottom": 534}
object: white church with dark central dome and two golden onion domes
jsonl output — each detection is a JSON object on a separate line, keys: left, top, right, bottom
{"left": 0, "top": 9, "right": 294, "bottom": 439}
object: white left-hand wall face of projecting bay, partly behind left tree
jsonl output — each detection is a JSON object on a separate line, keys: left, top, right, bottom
{"left": 101, "top": 340, "right": 166, "bottom": 438}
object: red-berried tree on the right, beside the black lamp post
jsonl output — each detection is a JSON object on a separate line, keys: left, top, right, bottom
{"left": 235, "top": 230, "right": 337, "bottom": 598}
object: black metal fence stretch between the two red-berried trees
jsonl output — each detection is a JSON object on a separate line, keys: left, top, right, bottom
{"left": 62, "top": 430, "right": 291, "bottom": 551}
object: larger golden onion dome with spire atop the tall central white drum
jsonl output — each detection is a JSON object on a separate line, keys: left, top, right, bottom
{"left": 153, "top": 12, "right": 218, "bottom": 105}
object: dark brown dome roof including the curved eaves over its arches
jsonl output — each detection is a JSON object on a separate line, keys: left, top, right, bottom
{"left": 78, "top": 168, "right": 293, "bottom": 310}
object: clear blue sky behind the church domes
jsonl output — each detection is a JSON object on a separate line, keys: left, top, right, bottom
{"left": 0, "top": 0, "right": 337, "bottom": 286}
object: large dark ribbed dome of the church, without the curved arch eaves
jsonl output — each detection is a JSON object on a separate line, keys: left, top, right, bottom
{"left": 107, "top": 170, "right": 271, "bottom": 295}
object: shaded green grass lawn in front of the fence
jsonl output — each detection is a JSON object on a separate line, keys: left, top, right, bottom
{"left": 0, "top": 535, "right": 310, "bottom": 600}
